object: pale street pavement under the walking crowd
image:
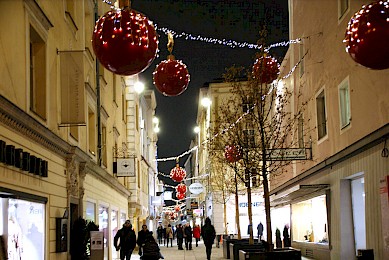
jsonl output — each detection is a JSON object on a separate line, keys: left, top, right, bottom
{"left": 131, "top": 240, "right": 224, "bottom": 260}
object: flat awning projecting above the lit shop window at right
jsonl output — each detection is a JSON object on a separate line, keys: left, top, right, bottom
{"left": 270, "top": 184, "right": 330, "bottom": 207}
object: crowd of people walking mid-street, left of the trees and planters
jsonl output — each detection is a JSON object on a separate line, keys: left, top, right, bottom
{"left": 114, "top": 218, "right": 216, "bottom": 260}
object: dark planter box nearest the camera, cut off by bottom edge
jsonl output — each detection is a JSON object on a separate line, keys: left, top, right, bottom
{"left": 239, "top": 247, "right": 301, "bottom": 260}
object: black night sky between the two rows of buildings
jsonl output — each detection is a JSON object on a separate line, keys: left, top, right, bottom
{"left": 131, "top": 0, "right": 288, "bottom": 174}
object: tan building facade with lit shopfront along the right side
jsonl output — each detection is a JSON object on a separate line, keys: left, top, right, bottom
{"left": 270, "top": 0, "right": 389, "bottom": 259}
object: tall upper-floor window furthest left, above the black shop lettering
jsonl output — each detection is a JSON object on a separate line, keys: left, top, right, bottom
{"left": 29, "top": 25, "right": 47, "bottom": 120}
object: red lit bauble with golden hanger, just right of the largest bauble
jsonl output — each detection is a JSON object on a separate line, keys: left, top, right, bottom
{"left": 153, "top": 33, "right": 190, "bottom": 96}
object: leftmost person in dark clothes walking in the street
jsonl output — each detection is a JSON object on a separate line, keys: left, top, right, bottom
{"left": 113, "top": 220, "right": 136, "bottom": 260}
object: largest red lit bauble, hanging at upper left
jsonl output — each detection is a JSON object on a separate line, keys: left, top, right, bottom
{"left": 92, "top": 8, "right": 158, "bottom": 76}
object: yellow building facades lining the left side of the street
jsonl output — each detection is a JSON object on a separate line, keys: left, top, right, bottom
{"left": 0, "top": 0, "right": 157, "bottom": 259}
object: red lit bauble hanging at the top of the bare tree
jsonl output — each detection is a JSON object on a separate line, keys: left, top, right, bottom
{"left": 253, "top": 56, "right": 280, "bottom": 84}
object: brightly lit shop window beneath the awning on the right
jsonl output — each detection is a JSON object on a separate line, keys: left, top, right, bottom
{"left": 292, "top": 195, "right": 328, "bottom": 244}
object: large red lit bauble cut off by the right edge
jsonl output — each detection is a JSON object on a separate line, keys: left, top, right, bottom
{"left": 343, "top": 1, "right": 389, "bottom": 70}
